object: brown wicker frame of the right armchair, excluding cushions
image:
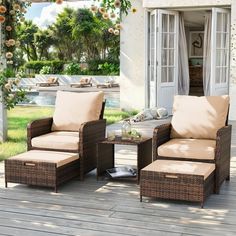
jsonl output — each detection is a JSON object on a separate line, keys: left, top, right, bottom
{"left": 153, "top": 95, "right": 232, "bottom": 193}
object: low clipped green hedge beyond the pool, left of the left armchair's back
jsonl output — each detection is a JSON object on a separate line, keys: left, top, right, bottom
{"left": 24, "top": 60, "right": 65, "bottom": 74}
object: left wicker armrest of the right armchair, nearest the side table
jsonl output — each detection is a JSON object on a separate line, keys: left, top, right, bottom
{"left": 152, "top": 123, "right": 171, "bottom": 160}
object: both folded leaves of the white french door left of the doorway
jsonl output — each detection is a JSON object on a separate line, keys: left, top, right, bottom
{"left": 149, "top": 10, "right": 179, "bottom": 113}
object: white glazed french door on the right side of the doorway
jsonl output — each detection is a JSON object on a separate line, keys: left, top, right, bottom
{"left": 210, "top": 8, "right": 230, "bottom": 95}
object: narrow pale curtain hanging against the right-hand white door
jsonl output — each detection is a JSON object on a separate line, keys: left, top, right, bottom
{"left": 203, "top": 13, "right": 212, "bottom": 96}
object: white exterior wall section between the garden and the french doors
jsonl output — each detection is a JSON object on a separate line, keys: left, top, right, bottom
{"left": 120, "top": 0, "right": 145, "bottom": 109}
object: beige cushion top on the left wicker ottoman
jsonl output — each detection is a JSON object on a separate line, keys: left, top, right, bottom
{"left": 9, "top": 150, "right": 79, "bottom": 167}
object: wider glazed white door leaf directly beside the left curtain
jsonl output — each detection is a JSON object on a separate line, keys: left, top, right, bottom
{"left": 157, "top": 10, "right": 179, "bottom": 114}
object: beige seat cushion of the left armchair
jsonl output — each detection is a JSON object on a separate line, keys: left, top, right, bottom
{"left": 31, "top": 131, "right": 79, "bottom": 151}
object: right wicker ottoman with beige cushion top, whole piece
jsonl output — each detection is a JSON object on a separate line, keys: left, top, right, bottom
{"left": 140, "top": 160, "right": 215, "bottom": 207}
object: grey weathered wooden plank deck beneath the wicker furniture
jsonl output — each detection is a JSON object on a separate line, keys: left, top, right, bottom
{"left": 0, "top": 123, "right": 236, "bottom": 236}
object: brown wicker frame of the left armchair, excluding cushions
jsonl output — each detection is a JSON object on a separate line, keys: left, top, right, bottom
{"left": 27, "top": 93, "right": 106, "bottom": 180}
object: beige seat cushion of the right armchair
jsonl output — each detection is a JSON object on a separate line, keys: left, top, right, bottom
{"left": 157, "top": 139, "right": 216, "bottom": 160}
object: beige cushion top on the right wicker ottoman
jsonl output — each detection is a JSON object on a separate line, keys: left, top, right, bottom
{"left": 143, "top": 160, "right": 215, "bottom": 179}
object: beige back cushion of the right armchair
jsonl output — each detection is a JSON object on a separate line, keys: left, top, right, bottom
{"left": 171, "top": 95, "right": 229, "bottom": 139}
